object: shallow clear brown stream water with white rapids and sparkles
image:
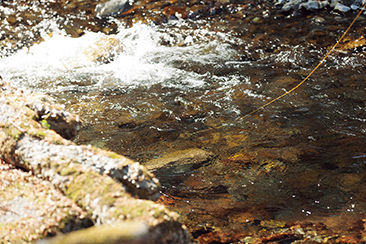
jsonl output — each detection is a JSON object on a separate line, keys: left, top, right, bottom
{"left": 0, "top": 0, "right": 366, "bottom": 240}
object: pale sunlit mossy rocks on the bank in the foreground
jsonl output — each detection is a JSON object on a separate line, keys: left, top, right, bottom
{"left": 0, "top": 83, "right": 190, "bottom": 243}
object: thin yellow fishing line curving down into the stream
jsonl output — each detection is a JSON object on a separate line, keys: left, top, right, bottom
{"left": 237, "top": 3, "right": 366, "bottom": 120}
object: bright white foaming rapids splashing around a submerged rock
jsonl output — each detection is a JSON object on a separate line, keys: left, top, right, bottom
{"left": 0, "top": 21, "right": 243, "bottom": 89}
